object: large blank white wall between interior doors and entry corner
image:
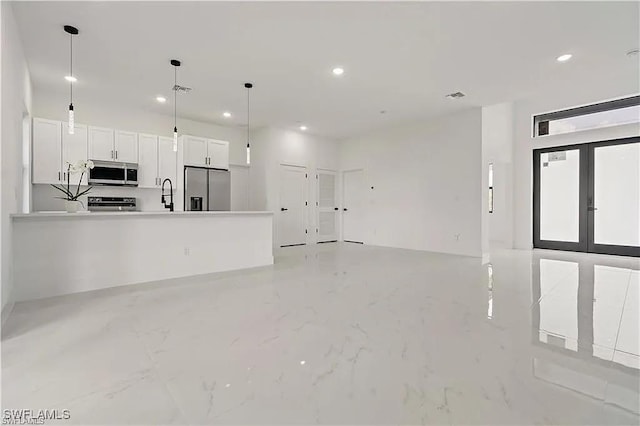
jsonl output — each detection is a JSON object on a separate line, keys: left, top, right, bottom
{"left": 340, "top": 108, "right": 484, "bottom": 257}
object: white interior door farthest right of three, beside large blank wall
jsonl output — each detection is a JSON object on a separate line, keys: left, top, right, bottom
{"left": 342, "top": 170, "right": 365, "bottom": 243}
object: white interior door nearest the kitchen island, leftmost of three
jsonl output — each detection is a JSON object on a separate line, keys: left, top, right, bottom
{"left": 276, "top": 165, "right": 307, "bottom": 247}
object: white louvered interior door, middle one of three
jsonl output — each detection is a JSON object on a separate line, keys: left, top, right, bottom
{"left": 317, "top": 170, "right": 338, "bottom": 243}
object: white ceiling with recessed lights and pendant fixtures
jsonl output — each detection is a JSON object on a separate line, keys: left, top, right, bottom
{"left": 13, "top": 1, "right": 640, "bottom": 139}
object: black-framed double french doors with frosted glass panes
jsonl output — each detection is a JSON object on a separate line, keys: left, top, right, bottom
{"left": 533, "top": 137, "right": 640, "bottom": 256}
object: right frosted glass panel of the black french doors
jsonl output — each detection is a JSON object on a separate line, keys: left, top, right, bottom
{"left": 593, "top": 143, "right": 640, "bottom": 246}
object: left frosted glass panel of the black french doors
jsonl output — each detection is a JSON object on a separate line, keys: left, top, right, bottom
{"left": 540, "top": 149, "right": 580, "bottom": 242}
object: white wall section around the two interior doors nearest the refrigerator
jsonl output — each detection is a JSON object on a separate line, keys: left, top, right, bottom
{"left": 249, "top": 127, "right": 340, "bottom": 245}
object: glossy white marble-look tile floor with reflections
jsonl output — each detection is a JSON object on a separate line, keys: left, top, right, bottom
{"left": 2, "top": 244, "right": 640, "bottom": 425}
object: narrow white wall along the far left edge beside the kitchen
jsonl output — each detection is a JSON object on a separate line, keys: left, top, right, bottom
{"left": 0, "top": 2, "right": 31, "bottom": 316}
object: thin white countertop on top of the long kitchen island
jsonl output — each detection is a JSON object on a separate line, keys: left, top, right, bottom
{"left": 11, "top": 211, "right": 273, "bottom": 219}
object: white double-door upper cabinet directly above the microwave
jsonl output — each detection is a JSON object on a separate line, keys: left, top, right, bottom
{"left": 89, "top": 127, "right": 138, "bottom": 163}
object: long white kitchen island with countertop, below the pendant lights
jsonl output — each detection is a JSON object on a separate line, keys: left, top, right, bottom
{"left": 12, "top": 212, "right": 273, "bottom": 301}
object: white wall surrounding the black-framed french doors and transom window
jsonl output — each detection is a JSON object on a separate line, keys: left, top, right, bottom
{"left": 513, "top": 89, "right": 640, "bottom": 249}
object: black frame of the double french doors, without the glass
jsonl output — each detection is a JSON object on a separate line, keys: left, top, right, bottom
{"left": 533, "top": 137, "right": 640, "bottom": 257}
